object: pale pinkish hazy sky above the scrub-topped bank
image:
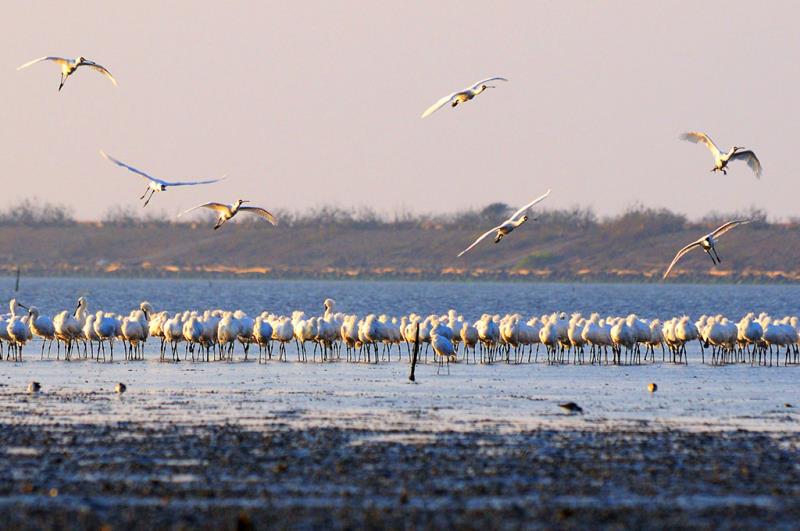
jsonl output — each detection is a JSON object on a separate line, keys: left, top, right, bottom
{"left": 0, "top": 0, "right": 800, "bottom": 219}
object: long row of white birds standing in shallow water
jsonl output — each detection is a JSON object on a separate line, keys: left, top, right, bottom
{"left": 0, "top": 297, "right": 800, "bottom": 365}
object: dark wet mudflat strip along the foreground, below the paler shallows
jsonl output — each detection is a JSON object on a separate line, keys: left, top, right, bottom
{"left": 0, "top": 422, "right": 800, "bottom": 529}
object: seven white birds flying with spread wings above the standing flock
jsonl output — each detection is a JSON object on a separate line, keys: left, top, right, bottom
{"left": 12, "top": 56, "right": 762, "bottom": 278}
